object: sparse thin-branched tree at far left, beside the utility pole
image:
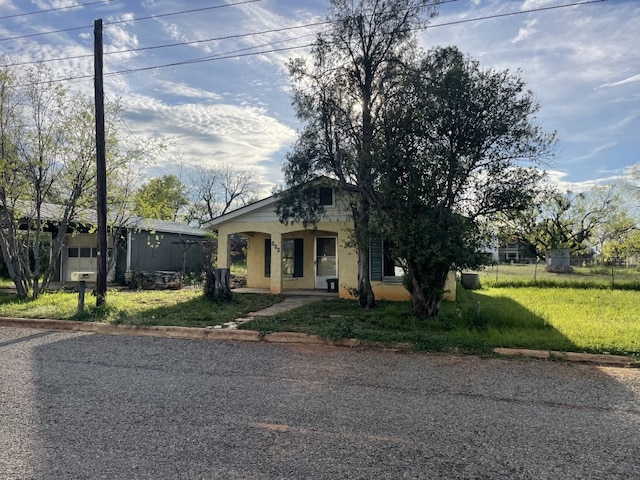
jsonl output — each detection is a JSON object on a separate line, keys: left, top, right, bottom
{"left": 0, "top": 66, "right": 158, "bottom": 298}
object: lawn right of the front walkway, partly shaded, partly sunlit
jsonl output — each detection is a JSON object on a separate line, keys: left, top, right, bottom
{"left": 241, "top": 288, "right": 640, "bottom": 355}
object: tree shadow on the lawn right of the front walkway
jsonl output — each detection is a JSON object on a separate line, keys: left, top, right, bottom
{"left": 240, "top": 289, "right": 576, "bottom": 353}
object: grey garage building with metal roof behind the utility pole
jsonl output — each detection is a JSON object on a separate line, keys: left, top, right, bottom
{"left": 11, "top": 204, "right": 207, "bottom": 283}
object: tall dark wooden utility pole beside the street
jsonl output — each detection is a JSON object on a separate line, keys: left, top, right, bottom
{"left": 93, "top": 19, "right": 107, "bottom": 307}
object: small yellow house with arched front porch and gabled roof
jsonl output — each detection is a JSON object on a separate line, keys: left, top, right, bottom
{"left": 204, "top": 186, "right": 455, "bottom": 300}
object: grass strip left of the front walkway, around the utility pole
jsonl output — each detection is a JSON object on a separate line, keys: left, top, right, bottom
{"left": 0, "top": 289, "right": 280, "bottom": 327}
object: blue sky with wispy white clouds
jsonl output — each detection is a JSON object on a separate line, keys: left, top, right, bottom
{"left": 0, "top": 0, "right": 640, "bottom": 196}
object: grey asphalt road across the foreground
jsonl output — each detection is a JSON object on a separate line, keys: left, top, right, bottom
{"left": 0, "top": 328, "right": 640, "bottom": 480}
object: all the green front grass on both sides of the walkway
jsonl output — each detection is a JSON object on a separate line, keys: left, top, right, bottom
{"left": 0, "top": 272, "right": 640, "bottom": 358}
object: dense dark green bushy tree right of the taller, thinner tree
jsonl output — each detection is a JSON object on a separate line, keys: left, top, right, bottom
{"left": 378, "top": 47, "right": 555, "bottom": 317}
